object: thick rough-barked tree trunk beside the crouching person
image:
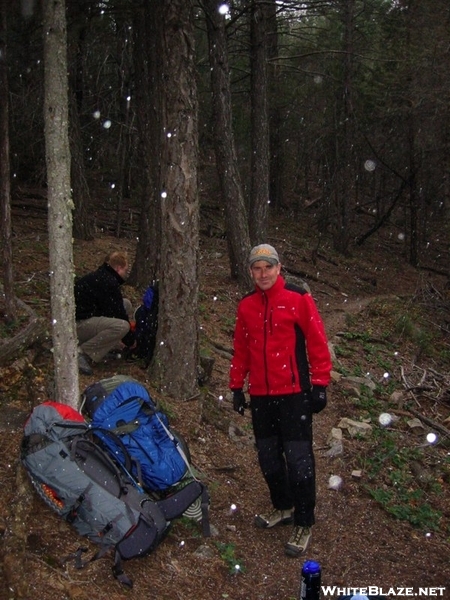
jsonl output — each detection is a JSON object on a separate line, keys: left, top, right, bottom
{"left": 151, "top": 0, "right": 199, "bottom": 399}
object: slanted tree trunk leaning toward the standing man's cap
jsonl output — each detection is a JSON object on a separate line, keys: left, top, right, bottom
{"left": 204, "top": 0, "right": 251, "bottom": 290}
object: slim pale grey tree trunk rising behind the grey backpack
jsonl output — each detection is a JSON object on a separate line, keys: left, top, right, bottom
{"left": 43, "top": 0, "right": 79, "bottom": 408}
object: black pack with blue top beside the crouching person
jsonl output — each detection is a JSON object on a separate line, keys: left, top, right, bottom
{"left": 131, "top": 283, "right": 159, "bottom": 367}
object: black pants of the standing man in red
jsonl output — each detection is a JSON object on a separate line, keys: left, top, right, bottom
{"left": 251, "top": 393, "right": 316, "bottom": 527}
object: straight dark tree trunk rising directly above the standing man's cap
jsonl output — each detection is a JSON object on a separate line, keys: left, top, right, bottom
{"left": 249, "top": 0, "right": 269, "bottom": 245}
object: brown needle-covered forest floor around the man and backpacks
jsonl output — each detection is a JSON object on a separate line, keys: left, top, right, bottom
{"left": 0, "top": 203, "right": 450, "bottom": 600}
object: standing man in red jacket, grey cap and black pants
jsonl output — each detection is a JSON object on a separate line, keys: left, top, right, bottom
{"left": 230, "top": 244, "right": 331, "bottom": 557}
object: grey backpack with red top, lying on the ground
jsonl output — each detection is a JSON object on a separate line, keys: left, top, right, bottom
{"left": 21, "top": 402, "right": 208, "bottom": 587}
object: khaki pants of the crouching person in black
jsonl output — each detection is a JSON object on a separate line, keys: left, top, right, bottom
{"left": 77, "top": 317, "right": 130, "bottom": 362}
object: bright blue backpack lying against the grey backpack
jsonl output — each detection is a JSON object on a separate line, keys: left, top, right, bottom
{"left": 81, "top": 375, "right": 209, "bottom": 535}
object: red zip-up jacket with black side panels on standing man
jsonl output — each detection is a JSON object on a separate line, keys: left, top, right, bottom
{"left": 230, "top": 275, "right": 331, "bottom": 396}
